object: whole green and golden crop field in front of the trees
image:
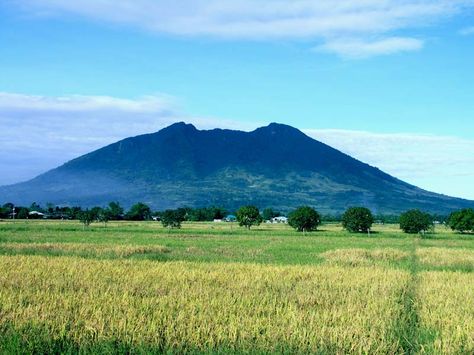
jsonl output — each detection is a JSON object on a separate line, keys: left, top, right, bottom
{"left": 0, "top": 221, "right": 474, "bottom": 354}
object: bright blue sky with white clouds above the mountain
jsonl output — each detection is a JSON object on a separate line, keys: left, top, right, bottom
{"left": 0, "top": 0, "right": 474, "bottom": 199}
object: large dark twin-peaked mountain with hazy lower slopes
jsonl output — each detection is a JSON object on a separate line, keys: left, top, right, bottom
{"left": 0, "top": 122, "right": 474, "bottom": 213}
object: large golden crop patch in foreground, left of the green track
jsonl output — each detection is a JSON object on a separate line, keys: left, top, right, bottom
{"left": 0, "top": 256, "right": 409, "bottom": 354}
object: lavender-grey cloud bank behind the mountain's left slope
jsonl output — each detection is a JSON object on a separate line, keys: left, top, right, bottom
{"left": 0, "top": 93, "right": 253, "bottom": 185}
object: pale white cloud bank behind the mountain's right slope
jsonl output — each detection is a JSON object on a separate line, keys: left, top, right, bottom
{"left": 304, "top": 129, "right": 474, "bottom": 199}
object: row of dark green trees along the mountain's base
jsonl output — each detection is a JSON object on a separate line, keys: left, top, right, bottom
{"left": 0, "top": 201, "right": 474, "bottom": 234}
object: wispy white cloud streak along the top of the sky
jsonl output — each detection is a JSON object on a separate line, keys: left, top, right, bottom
{"left": 14, "top": 0, "right": 474, "bottom": 57}
